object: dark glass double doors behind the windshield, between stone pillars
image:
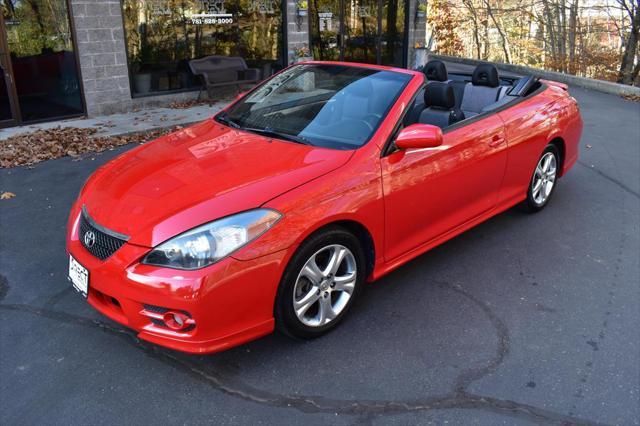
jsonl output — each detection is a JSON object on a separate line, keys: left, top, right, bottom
{"left": 309, "top": 0, "right": 406, "bottom": 67}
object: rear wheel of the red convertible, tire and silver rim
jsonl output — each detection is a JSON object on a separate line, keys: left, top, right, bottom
{"left": 524, "top": 144, "right": 560, "bottom": 213}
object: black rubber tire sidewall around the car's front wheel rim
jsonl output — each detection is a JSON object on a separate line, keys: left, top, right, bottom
{"left": 274, "top": 226, "right": 366, "bottom": 339}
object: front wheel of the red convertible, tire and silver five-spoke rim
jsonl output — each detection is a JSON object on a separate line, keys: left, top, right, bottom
{"left": 274, "top": 226, "right": 366, "bottom": 339}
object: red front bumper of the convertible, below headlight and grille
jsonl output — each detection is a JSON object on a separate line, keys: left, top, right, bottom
{"left": 67, "top": 208, "right": 286, "bottom": 353}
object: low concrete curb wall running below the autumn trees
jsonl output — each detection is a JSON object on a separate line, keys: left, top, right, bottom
{"left": 429, "top": 54, "right": 640, "bottom": 96}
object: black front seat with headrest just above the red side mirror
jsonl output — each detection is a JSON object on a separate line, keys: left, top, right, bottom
{"left": 418, "top": 81, "right": 464, "bottom": 129}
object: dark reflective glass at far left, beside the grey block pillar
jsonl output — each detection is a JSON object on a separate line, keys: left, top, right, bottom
{"left": 0, "top": 0, "right": 84, "bottom": 123}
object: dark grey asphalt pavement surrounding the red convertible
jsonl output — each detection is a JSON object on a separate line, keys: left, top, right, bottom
{"left": 0, "top": 85, "right": 640, "bottom": 425}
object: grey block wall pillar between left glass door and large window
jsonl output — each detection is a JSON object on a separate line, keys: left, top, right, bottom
{"left": 71, "top": 0, "right": 132, "bottom": 116}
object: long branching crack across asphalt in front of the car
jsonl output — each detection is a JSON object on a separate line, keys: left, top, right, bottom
{"left": 0, "top": 298, "right": 599, "bottom": 425}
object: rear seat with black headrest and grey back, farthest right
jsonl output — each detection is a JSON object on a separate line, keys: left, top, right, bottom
{"left": 460, "top": 64, "right": 508, "bottom": 118}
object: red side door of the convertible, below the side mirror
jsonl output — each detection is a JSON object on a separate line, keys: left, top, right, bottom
{"left": 382, "top": 115, "right": 507, "bottom": 261}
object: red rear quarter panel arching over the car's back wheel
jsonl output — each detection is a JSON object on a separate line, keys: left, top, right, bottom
{"left": 498, "top": 83, "right": 582, "bottom": 203}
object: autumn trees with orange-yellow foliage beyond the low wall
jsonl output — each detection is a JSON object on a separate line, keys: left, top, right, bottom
{"left": 426, "top": 0, "right": 640, "bottom": 85}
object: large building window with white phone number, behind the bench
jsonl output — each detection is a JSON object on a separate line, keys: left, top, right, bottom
{"left": 122, "top": 0, "right": 283, "bottom": 96}
